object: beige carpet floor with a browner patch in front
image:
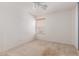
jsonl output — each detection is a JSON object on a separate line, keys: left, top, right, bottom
{"left": 0, "top": 40, "right": 77, "bottom": 56}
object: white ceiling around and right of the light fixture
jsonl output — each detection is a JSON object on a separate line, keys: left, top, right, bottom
{"left": 29, "top": 2, "right": 76, "bottom": 14}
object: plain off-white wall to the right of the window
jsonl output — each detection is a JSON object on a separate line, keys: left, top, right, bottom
{"left": 38, "top": 10, "right": 74, "bottom": 44}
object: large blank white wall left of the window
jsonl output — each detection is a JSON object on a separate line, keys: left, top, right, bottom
{"left": 0, "top": 3, "right": 35, "bottom": 51}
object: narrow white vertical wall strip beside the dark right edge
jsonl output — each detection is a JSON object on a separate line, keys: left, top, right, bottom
{"left": 73, "top": 3, "right": 78, "bottom": 49}
